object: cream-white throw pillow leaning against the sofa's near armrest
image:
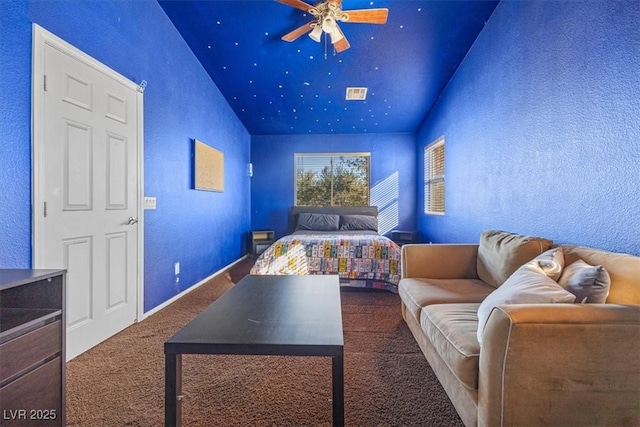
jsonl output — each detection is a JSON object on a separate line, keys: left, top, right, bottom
{"left": 478, "top": 248, "right": 576, "bottom": 343}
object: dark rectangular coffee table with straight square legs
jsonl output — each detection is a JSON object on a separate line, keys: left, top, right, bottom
{"left": 164, "top": 276, "right": 344, "bottom": 426}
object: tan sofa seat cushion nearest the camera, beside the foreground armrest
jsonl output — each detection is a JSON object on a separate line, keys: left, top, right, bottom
{"left": 420, "top": 304, "right": 480, "bottom": 390}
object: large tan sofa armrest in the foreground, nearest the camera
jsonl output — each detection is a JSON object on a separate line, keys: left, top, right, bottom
{"left": 478, "top": 304, "right": 640, "bottom": 426}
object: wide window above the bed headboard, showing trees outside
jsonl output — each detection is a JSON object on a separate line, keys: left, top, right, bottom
{"left": 295, "top": 153, "right": 370, "bottom": 206}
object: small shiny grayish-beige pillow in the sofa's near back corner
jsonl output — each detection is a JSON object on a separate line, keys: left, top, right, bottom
{"left": 558, "top": 259, "right": 611, "bottom": 304}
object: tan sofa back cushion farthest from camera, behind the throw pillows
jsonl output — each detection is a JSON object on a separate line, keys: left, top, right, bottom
{"left": 477, "top": 230, "right": 553, "bottom": 288}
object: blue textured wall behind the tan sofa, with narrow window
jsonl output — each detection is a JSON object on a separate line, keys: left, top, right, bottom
{"left": 418, "top": 1, "right": 640, "bottom": 255}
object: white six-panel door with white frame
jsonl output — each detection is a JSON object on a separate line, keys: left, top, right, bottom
{"left": 33, "top": 29, "right": 141, "bottom": 360}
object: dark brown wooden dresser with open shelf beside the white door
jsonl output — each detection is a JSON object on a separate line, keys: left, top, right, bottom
{"left": 0, "top": 269, "right": 66, "bottom": 426}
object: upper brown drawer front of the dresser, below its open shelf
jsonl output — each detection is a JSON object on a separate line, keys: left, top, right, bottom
{"left": 0, "top": 320, "right": 62, "bottom": 382}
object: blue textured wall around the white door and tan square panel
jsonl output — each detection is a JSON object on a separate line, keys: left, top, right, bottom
{"left": 0, "top": 0, "right": 251, "bottom": 311}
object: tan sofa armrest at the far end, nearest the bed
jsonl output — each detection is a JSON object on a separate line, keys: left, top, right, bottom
{"left": 400, "top": 244, "right": 478, "bottom": 279}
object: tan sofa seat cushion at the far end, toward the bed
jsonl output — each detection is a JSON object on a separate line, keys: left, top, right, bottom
{"left": 398, "top": 278, "right": 493, "bottom": 321}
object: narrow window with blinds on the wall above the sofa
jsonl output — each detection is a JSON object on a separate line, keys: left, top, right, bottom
{"left": 424, "top": 136, "right": 444, "bottom": 215}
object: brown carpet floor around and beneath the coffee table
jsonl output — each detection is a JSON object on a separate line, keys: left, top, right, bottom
{"left": 67, "top": 260, "right": 462, "bottom": 426}
